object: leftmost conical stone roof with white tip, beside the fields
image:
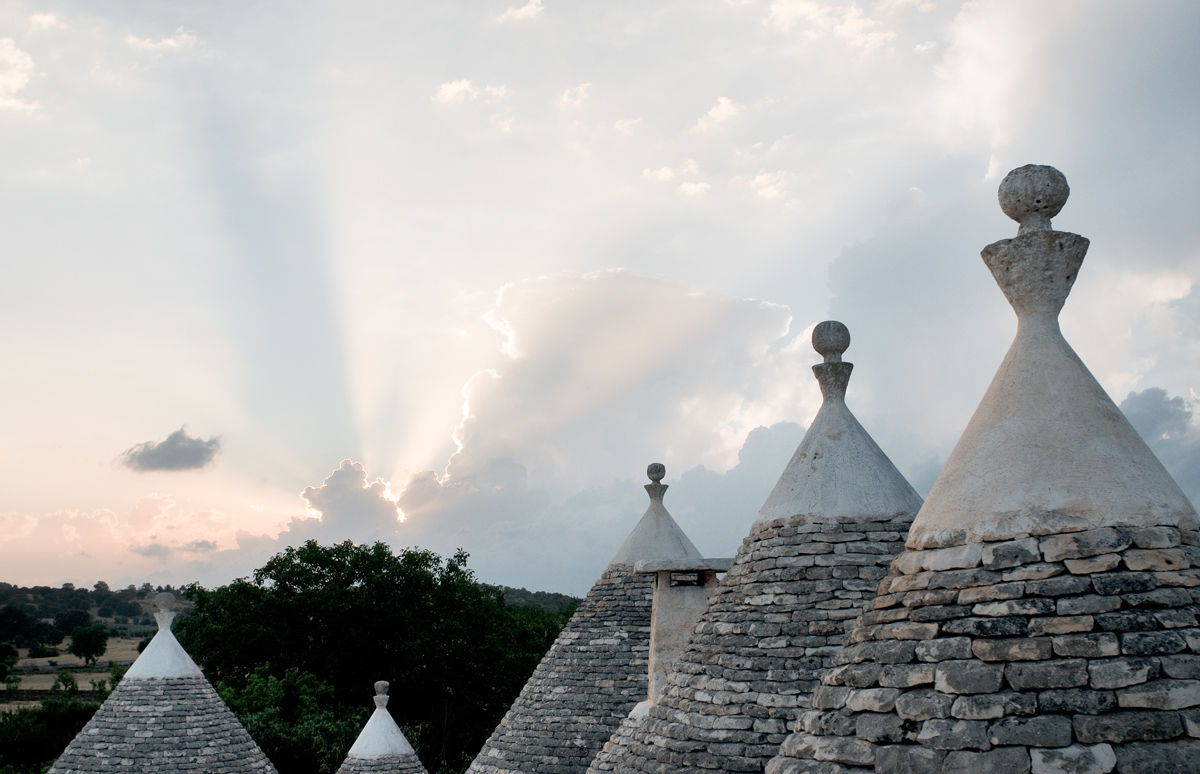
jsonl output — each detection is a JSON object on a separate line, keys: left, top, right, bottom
{"left": 50, "top": 595, "right": 275, "bottom": 774}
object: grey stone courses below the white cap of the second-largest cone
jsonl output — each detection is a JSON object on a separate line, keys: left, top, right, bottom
{"left": 594, "top": 515, "right": 912, "bottom": 772}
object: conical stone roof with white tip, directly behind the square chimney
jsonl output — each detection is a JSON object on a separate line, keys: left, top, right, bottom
{"left": 468, "top": 463, "right": 701, "bottom": 774}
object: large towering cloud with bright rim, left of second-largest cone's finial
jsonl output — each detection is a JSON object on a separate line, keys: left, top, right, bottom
{"left": 446, "top": 271, "right": 816, "bottom": 487}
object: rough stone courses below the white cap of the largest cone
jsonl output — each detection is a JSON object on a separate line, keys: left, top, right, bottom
{"left": 767, "top": 527, "right": 1200, "bottom": 774}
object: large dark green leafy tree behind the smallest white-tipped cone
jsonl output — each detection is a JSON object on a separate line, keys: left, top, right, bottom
{"left": 175, "top": 541, "right": 565, "bottom": 774}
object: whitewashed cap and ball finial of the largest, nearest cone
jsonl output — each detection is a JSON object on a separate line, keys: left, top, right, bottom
{"left": 908, "top": 166, "right": 1196, "bottom": 548}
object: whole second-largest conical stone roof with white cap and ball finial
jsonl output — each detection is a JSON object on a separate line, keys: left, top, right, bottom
{"left": 595, "top": 322, "right": 920, "bottom": 773}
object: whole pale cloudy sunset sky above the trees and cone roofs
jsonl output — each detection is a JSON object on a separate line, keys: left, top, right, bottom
{"left": 0, "top": 0, "right": 1200, "bottom": 594}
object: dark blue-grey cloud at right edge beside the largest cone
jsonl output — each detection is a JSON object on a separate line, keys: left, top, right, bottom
{"left": 1121, "top": 388, "right": 1200, "bottom": 505}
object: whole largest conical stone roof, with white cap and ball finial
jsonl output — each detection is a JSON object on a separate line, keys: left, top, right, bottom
{"left": 767, "top": 166, "right": 1200, "bottom": 774}
